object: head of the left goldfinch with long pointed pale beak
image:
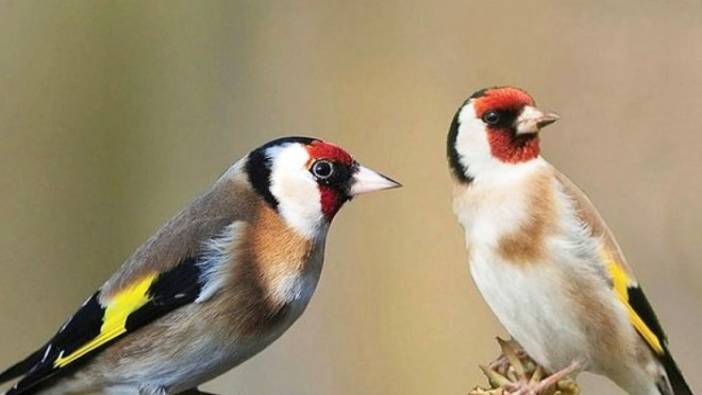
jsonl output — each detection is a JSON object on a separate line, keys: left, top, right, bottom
{"left": 244, "top": 137, "right": 400, "bottom": 237}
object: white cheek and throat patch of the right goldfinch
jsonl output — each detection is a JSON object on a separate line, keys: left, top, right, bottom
{"left": 456, "top": 100, "right": 545, "bottom": 182}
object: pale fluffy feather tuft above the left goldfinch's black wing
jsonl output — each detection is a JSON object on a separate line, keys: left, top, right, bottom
{"left": 195, "top": 221, "right": 248, "bottom": 303}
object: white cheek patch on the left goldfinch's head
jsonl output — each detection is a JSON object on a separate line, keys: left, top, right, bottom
{"left": 266, "top": 143, "right": 327, "bottom": 240}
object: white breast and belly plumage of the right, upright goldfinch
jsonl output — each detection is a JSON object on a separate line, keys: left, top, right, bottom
{"left": 454, "top": 162, "right": 594, "bottom": 370}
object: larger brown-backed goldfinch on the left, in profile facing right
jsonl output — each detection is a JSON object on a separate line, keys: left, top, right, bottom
{"left": 0, "top": 136, "right": 401, "bottom": 395}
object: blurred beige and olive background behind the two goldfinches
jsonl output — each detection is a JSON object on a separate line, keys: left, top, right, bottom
{"left": 0, "top": 0, "right": 702, "bottom": 395}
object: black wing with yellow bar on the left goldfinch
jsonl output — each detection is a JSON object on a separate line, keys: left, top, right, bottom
{"left": 0, "top": 257, "right": 202, "bottom": 395}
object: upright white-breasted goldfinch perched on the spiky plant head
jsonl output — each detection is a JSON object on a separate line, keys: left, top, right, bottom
{"left": 447, "top": 86, "right": 692, "bottom": 395}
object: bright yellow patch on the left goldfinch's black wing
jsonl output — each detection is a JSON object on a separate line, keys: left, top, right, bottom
{"left": 54, "top": 274, "right": 157, "bottom": 368}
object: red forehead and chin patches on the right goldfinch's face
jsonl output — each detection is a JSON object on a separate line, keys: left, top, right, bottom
{"left": 473, "top": 87, "right": 540, "bottom": 163}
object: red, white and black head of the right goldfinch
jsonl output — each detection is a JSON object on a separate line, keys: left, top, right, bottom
{"left": 447, "top": 87, "right": 558, "bottom": 181}
